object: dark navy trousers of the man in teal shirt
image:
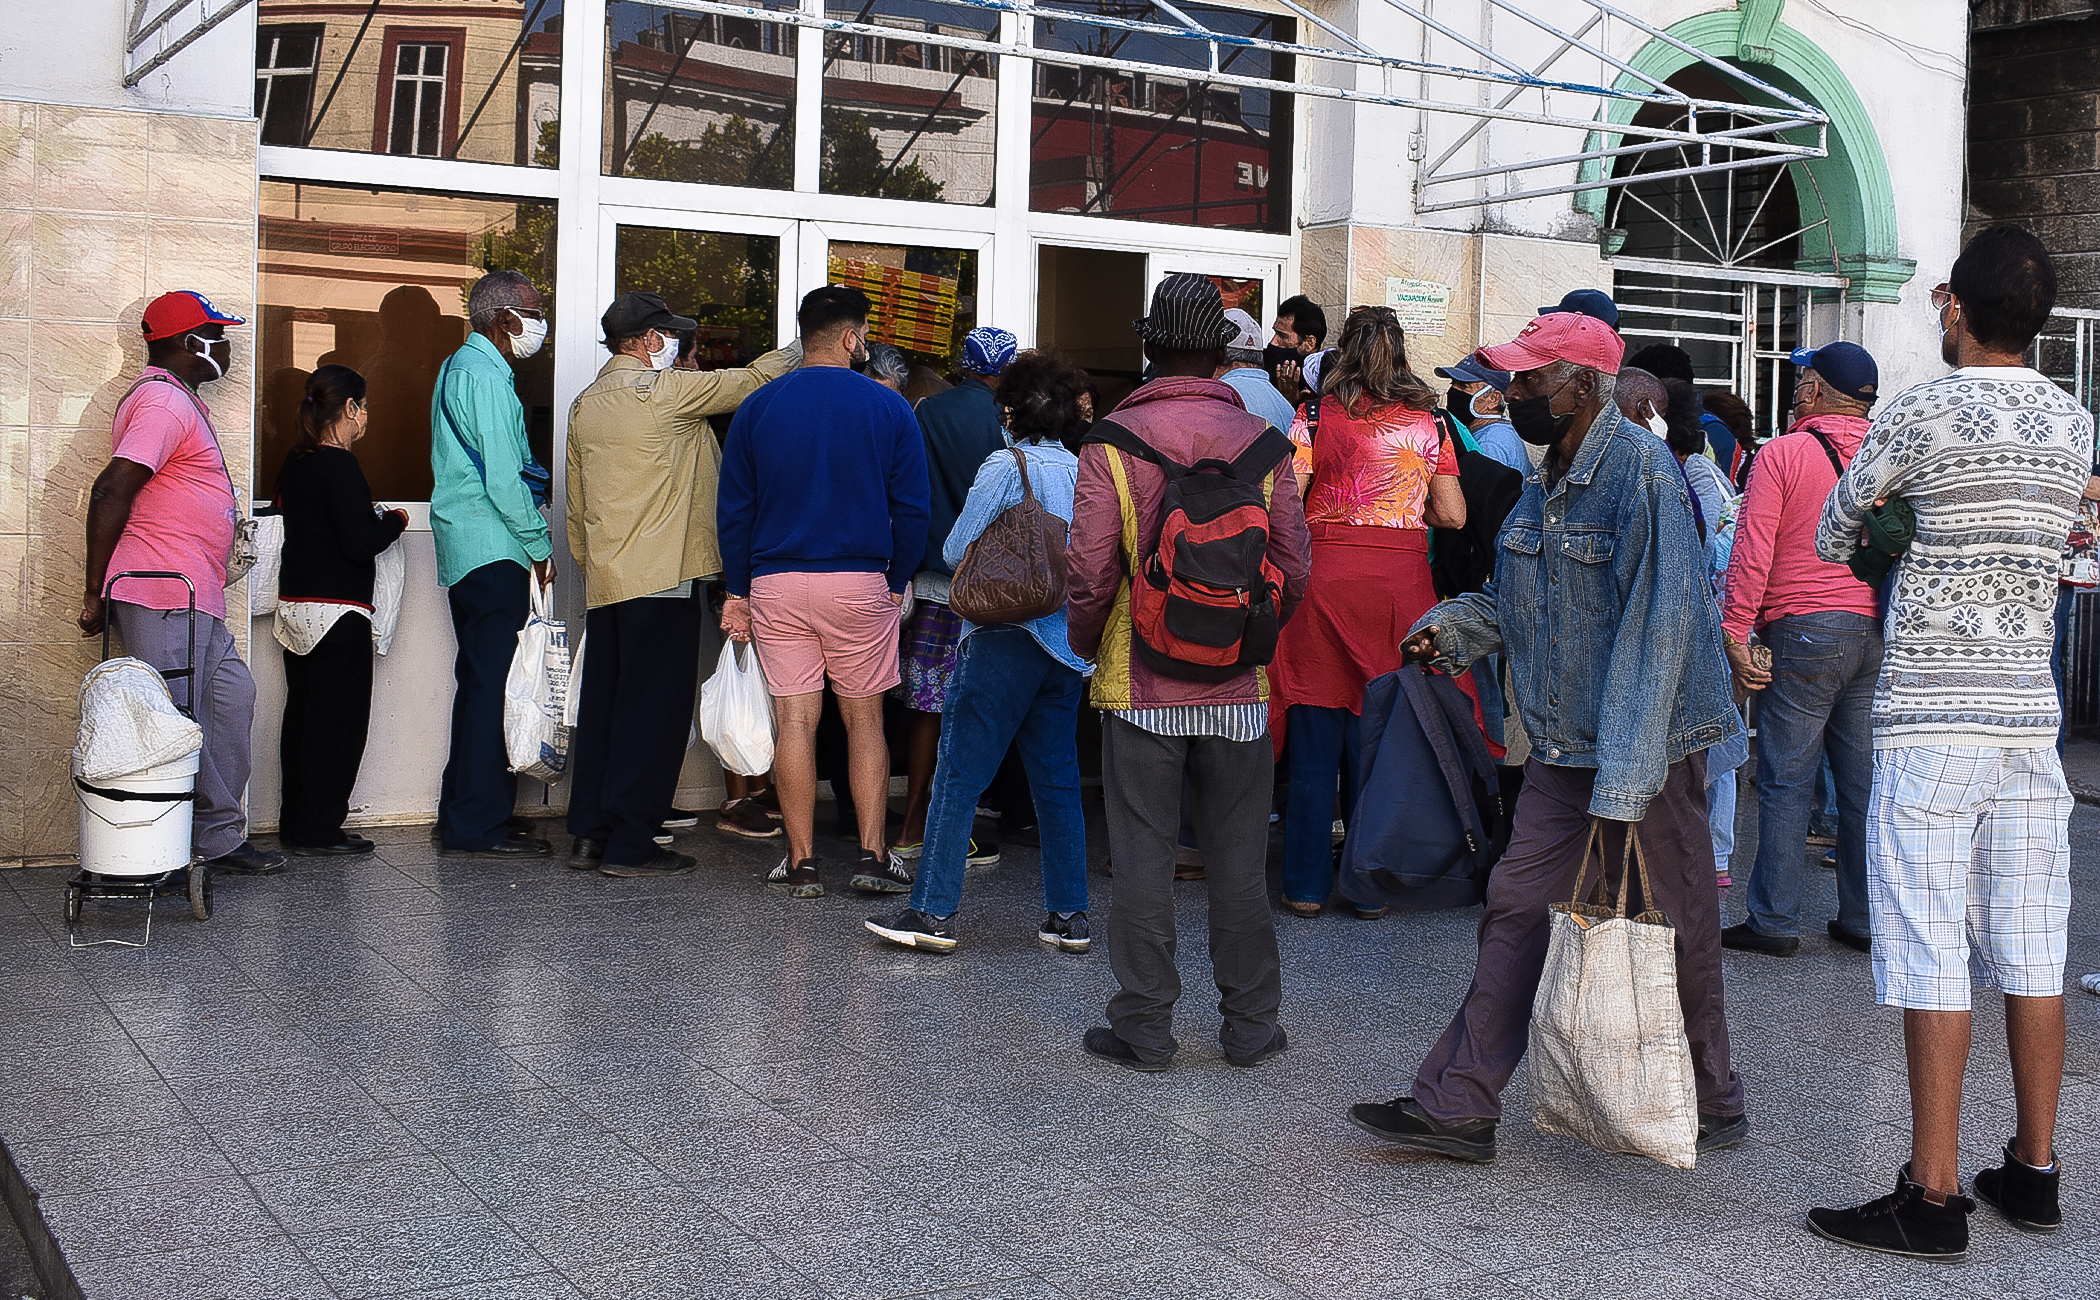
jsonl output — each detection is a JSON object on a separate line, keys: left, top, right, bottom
{"left": 437, "top": 561, "right": 531, "bottom": 851}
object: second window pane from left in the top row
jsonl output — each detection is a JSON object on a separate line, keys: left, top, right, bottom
{"left": 601, "top": 0, "right": 796, "bottom": 189}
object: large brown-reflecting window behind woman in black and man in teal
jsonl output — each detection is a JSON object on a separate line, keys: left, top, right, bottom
{"left": 254, "top": 181, "right": 558, "bottom": 502}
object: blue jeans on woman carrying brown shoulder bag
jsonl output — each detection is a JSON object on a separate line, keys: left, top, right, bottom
{"left": 911, "top": 628, "right": 1086, "bottom": 916}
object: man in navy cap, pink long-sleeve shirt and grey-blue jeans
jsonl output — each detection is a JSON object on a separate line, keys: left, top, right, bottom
{"left": 1720, "top": 342, "right": 1882, "bottom": 958}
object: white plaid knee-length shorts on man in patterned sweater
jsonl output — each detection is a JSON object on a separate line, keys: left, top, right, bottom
{"left": 1867, "top": 746, "right": 2071, "bottom": 1010}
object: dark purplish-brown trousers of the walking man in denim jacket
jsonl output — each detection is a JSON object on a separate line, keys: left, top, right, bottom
{"left": 1419, "top": 754, "right": 1743, "bottom": 1124}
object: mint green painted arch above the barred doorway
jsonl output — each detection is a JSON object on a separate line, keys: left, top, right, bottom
{"left": 1577, "top": 11, "right": 1917, "bottom": 302}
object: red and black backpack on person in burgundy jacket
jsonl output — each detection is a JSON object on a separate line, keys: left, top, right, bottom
{"left": 1086, "top": 420, "right": 1292, "bottom": 683}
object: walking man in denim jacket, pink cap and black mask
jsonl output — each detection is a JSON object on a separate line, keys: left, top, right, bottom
{"left": 1350, "top": 313, "right": 1749, "bottom": 1161}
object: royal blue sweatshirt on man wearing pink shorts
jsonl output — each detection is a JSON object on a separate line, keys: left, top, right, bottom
{"left": 714, "top": 365, "right": 928, "bottom": 596}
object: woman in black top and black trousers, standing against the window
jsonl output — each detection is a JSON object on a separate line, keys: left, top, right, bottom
{"left": 277, "top": 365, "right": 407, "bottom": 857}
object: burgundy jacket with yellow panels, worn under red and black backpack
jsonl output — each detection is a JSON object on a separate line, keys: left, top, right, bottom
{"left": 1065, "top": 378, "right": 1313, "bottom": 710}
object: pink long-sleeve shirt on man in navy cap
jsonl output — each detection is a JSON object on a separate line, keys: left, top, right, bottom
{"left": 1720, "top": 416, "right": 1877, "bottom": 641}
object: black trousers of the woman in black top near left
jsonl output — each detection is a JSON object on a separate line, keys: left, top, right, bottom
{"left": 277, "top": 613, "right": 372, "bottom": 848}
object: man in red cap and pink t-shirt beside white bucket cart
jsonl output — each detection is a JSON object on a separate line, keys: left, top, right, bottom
{"left": 80, "top": 290, "right": 284, "bottom": 876}
